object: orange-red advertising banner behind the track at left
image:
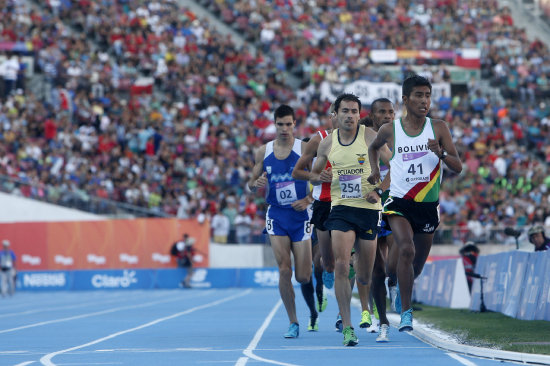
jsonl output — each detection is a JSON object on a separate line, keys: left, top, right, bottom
{"left": 0, "top": 218, "right": 210, "bottom": 271}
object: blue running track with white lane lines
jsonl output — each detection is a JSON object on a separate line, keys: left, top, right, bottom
{"left": 0, "top": 288, "right": 516, "bottom": 366}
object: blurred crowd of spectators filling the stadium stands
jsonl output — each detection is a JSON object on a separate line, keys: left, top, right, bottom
{"left": 0, "top": 0, "right": 550, "bottom": 242}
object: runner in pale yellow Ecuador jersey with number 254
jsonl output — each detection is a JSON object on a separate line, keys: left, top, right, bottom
{"left": 310, "top": 94, "right": 391, "bottom": 346}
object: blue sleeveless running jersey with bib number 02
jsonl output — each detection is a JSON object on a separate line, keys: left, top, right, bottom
{"left": 263, "top": 138, "right": 309, "bottom": 208}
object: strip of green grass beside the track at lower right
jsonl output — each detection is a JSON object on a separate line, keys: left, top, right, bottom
{"left": 414, "top": 304, "right": 550, "bottom": 355}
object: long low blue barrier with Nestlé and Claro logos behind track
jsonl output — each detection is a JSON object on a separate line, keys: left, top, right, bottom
{"left": 16, "top": 268, "right": 286, "bottom": 291}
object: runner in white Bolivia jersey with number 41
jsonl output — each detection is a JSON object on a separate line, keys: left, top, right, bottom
{"left": 368, "top": 75, "right": 462, "bottom": 331}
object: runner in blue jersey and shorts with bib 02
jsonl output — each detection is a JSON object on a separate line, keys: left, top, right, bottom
{"left": 247, "top": 105, "right": 312, "bottom": 338}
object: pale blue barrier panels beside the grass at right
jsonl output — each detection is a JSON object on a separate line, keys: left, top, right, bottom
{"left": 470, "top": 251, "right": 550, "bottom": 320}
